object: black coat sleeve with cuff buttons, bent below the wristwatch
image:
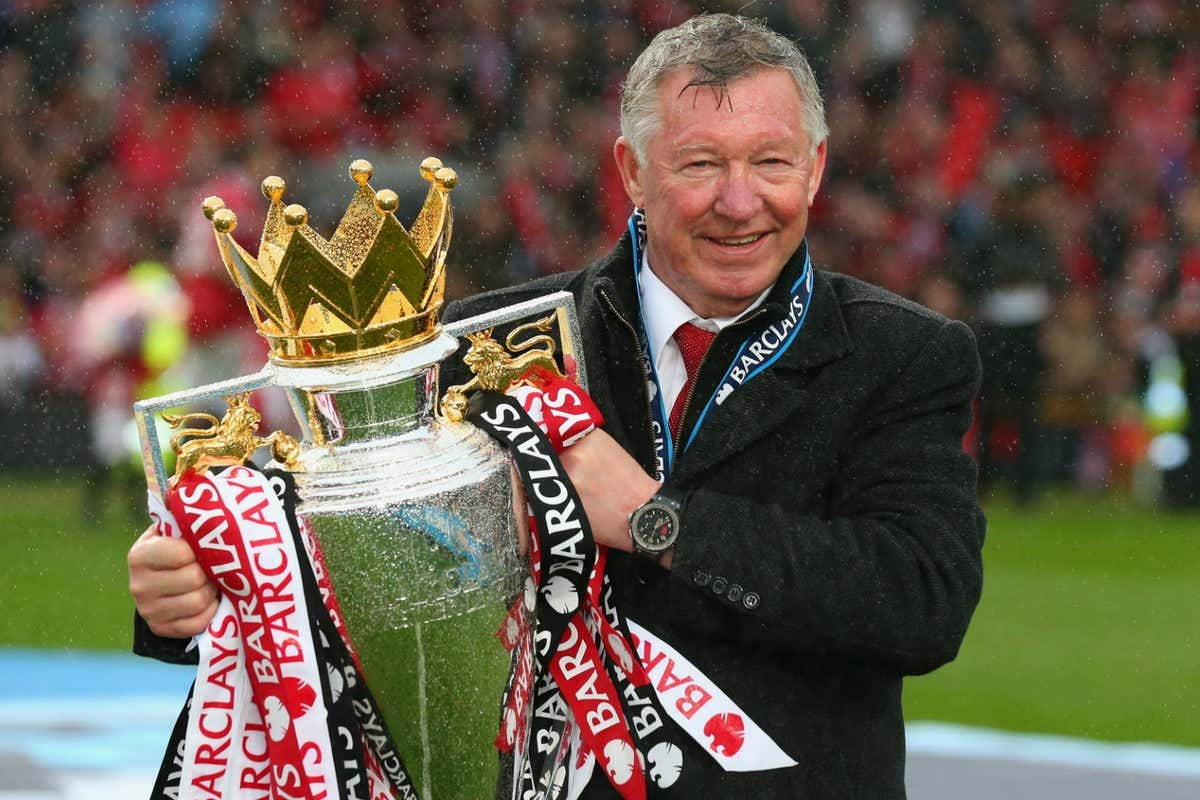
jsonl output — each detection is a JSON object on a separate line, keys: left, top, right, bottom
{"left": 673, "top": 321, "right": 985, "bottom": 674}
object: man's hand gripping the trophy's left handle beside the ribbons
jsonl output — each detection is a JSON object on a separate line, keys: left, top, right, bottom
{"left": 126, "top": 525, "right": 218, "bottom": 639}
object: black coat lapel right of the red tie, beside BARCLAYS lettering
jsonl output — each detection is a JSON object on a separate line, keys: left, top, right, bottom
{"left": 672, "top": 272, "right": 853, "bottom": 483}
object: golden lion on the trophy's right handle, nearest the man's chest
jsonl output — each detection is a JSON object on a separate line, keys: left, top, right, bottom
{"left": 442, "top": 314, "right": 565, "bottom": 422}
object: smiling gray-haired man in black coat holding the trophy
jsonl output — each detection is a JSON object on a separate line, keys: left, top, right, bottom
{"left": 130, "top": 14, "right": 984, "bottom": 800}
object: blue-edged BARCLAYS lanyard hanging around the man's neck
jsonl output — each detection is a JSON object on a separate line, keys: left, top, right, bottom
{"left": 629, "top": 209, "right": 812, "bottom": 483}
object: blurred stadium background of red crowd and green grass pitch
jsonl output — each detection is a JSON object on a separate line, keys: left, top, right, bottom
{"left": 0, "top": 0, "right": 1200, "bottom": 796}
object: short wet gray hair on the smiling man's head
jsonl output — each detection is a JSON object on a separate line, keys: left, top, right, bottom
{"left": 620, "top": 14, "right": 829, "bottom": 164}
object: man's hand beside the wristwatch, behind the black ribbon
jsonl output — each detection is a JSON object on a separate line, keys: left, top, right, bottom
{"left": 558, "top": 429, "right": 659, "bottom": 553}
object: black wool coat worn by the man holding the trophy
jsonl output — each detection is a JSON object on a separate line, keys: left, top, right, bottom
{"left": 443, "top": 235, "right": 985, "bottom": 800}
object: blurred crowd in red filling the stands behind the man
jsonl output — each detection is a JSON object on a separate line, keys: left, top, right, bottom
{"left": 0, "top": 0, "right": 1200, "bottom": 504}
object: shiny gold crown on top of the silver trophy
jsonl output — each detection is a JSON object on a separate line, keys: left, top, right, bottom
{"left": 203, "top": 158, "right": 457, "bottom": 366}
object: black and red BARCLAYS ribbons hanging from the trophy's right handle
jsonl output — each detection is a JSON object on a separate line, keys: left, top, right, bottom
{"left": 468, "top": 377, "right": 683, "bottom": 800}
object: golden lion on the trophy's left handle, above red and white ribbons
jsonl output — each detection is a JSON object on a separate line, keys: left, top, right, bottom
{"left": 162, "top": 392, "right": 300, "bottom": 482}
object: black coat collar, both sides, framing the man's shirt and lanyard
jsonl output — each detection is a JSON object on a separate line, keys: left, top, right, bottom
{"left": 580, "top": 234, "right": 853, "bottom": 485}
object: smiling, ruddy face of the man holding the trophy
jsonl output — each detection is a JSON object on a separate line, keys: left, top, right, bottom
{"left": 613, "top": 67, "right": 826, "bottom": 317}
